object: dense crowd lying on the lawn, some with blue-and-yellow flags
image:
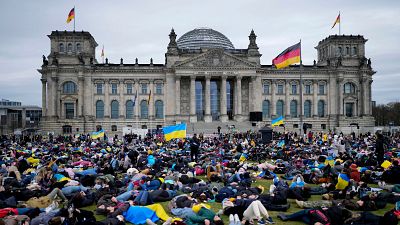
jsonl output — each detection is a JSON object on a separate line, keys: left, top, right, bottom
{"left": 0, "top": 128, "right": 400, "bottom": 225}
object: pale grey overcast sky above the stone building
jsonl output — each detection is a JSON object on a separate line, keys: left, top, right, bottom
{"left": 0, "top": 0, "right": 400, "bottom": 106}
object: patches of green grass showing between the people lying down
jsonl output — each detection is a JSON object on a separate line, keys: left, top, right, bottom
{"left": 83, "top": 177, "right": 394, "bottom": 225}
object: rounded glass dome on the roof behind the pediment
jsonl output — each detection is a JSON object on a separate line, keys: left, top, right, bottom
{"left": 177, "top": 28, "right": 235, "bottom": 49}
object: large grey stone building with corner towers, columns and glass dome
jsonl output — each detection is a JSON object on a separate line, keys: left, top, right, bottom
{"left": 39, "top": 28, "right": 375, "bottom": 133}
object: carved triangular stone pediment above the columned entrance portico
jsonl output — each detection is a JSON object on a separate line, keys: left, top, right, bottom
{"left": 175, "top": 49, "right": 256, "bottom": 68}
